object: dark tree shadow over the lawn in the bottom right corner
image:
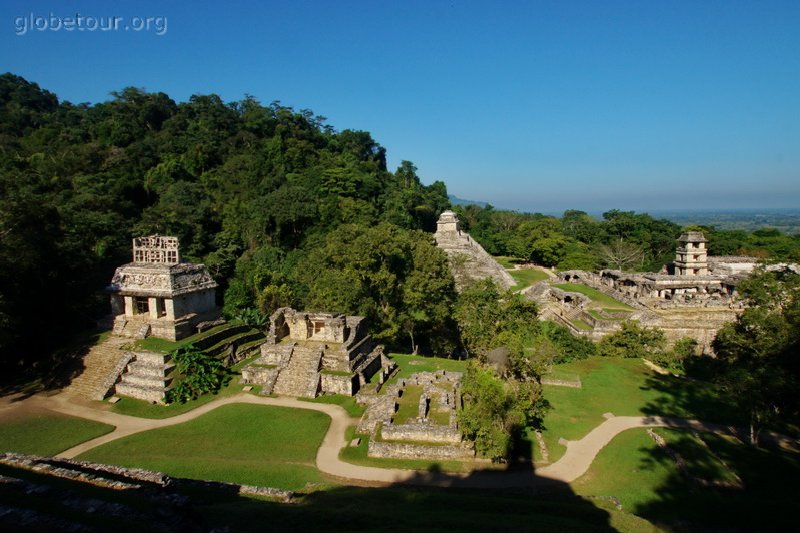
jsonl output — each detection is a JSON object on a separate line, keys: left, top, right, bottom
{"left": 631, "top": 431, "right": 800, "bottom": 531}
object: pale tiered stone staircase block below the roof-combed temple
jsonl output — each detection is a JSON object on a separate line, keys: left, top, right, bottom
{"left": 115, "top": 352, "right": 175, "bottom": 403}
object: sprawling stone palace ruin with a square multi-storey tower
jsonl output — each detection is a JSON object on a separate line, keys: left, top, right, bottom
{"left": 527, "top": 231, "right": 757, "bottom": 352}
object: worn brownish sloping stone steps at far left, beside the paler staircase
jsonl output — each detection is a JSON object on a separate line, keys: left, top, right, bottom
{"left": 64, "top": 335, "right": 130, "bottom": 400}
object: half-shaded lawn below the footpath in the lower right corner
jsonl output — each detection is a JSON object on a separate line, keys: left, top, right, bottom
{"left": 572, "top": 428, "right": 800, "bottom": 531}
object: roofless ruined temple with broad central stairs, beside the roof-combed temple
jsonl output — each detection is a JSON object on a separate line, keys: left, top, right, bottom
{"left": 242, "top": 307, "right": 387, "bottom": 398}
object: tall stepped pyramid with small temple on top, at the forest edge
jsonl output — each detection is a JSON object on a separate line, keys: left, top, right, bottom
{"left": 434, "top": 211, "right": 516, "bottom": 290}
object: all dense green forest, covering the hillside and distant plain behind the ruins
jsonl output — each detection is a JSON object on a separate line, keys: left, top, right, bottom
{"left": 0, "top": 74, "right": 800, "bottom": 374}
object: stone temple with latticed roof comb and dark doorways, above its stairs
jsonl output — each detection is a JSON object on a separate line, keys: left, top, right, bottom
{"left": 107, "top": 235, "right": 219, "bottom": 341}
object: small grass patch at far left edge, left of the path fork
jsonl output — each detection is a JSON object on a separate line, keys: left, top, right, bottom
{"left": 0, "top": 411, "right": 114, "bottom": 456}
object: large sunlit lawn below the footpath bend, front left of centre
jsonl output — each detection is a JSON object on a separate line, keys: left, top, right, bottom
{"left": 79, "top": 405, "right": 330, "bottom": 490}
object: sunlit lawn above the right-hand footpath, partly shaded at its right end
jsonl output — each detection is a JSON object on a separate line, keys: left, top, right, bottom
{"left": 537, "top": 356, "right": 746, "bottom": 461}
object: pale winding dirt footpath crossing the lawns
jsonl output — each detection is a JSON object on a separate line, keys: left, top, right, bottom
{"left": 3, "top": 394, "right": 748, "bottom": 488}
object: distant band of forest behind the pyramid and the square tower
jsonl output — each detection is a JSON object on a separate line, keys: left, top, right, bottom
{"left": 455, "top": 205, "right": 800, "bottom": 272}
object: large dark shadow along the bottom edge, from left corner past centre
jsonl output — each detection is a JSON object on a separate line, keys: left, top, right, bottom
{"left": 0, "top": 448, "right": 615, "bottom": 532}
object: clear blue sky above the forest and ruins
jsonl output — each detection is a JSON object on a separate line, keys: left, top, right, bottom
{"left": 0, "top": 0, "right": 800, "bottom": 212}
